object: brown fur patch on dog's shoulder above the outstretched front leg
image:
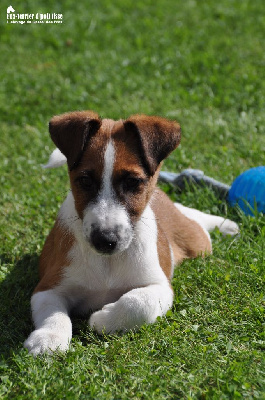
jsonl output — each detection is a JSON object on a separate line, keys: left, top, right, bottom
{"left": 34, "top": 220, "right": 75, "bottom": 293}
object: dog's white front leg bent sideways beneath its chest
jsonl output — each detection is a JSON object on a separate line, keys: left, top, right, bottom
{"left": 89, "top": 283, "right": 173, "bottom": 333}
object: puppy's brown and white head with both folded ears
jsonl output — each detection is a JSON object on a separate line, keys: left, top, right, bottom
{"left": 49, "top": 111, "right": 180, "bottom": 255}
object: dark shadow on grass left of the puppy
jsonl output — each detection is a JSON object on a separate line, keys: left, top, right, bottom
{"left": 0, "top": 253, "right": 38, "bottom": 356}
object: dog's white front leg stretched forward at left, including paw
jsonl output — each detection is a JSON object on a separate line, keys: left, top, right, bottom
{"left": 24, "top": 289, "right": 72, "bottom": 356}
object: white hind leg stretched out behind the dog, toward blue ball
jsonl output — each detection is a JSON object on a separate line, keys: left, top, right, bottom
{"left": 174, "top": 203, "right": 239, "bottom": 236}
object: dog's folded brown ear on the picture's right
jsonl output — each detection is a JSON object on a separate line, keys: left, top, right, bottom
{"left": 124, "top": 115, "right": 181, "bottom": 175}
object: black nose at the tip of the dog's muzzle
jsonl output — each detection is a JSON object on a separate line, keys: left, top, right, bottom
{"left": 91, "top": 229, "right": 118, "bottom": 254}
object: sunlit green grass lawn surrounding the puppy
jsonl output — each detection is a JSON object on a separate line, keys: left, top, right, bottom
{"left": 0, "top": 0, "right": 265, "bottom": 400}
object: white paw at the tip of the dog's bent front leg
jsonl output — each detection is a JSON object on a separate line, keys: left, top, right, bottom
{"left": 89, "top": 303, "right": 117, "bottom": 333}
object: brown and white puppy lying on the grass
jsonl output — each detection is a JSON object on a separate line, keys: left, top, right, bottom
{"left": 25, "top": 111, "right": 238, "bottom": 355}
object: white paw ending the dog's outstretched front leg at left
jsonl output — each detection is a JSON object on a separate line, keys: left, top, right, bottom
{"left": 24, "top": 329, "right": 69, "bottom": 356}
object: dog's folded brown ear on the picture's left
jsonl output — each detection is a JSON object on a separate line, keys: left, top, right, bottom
{"left": 49, "top": 111, "right": 101, "bottom": 171}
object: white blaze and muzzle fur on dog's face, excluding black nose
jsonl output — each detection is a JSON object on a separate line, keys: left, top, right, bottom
{"left": 83, "top": 140, "right": 133, "bottom": 253}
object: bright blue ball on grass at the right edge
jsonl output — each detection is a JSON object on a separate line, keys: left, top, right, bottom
{"left": 228, "top": 166, "right": 265, "bottom": 215}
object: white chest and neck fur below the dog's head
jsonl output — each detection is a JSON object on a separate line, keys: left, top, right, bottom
{"left": 56, "top": 203, "right": 166, "bottom": 313}
